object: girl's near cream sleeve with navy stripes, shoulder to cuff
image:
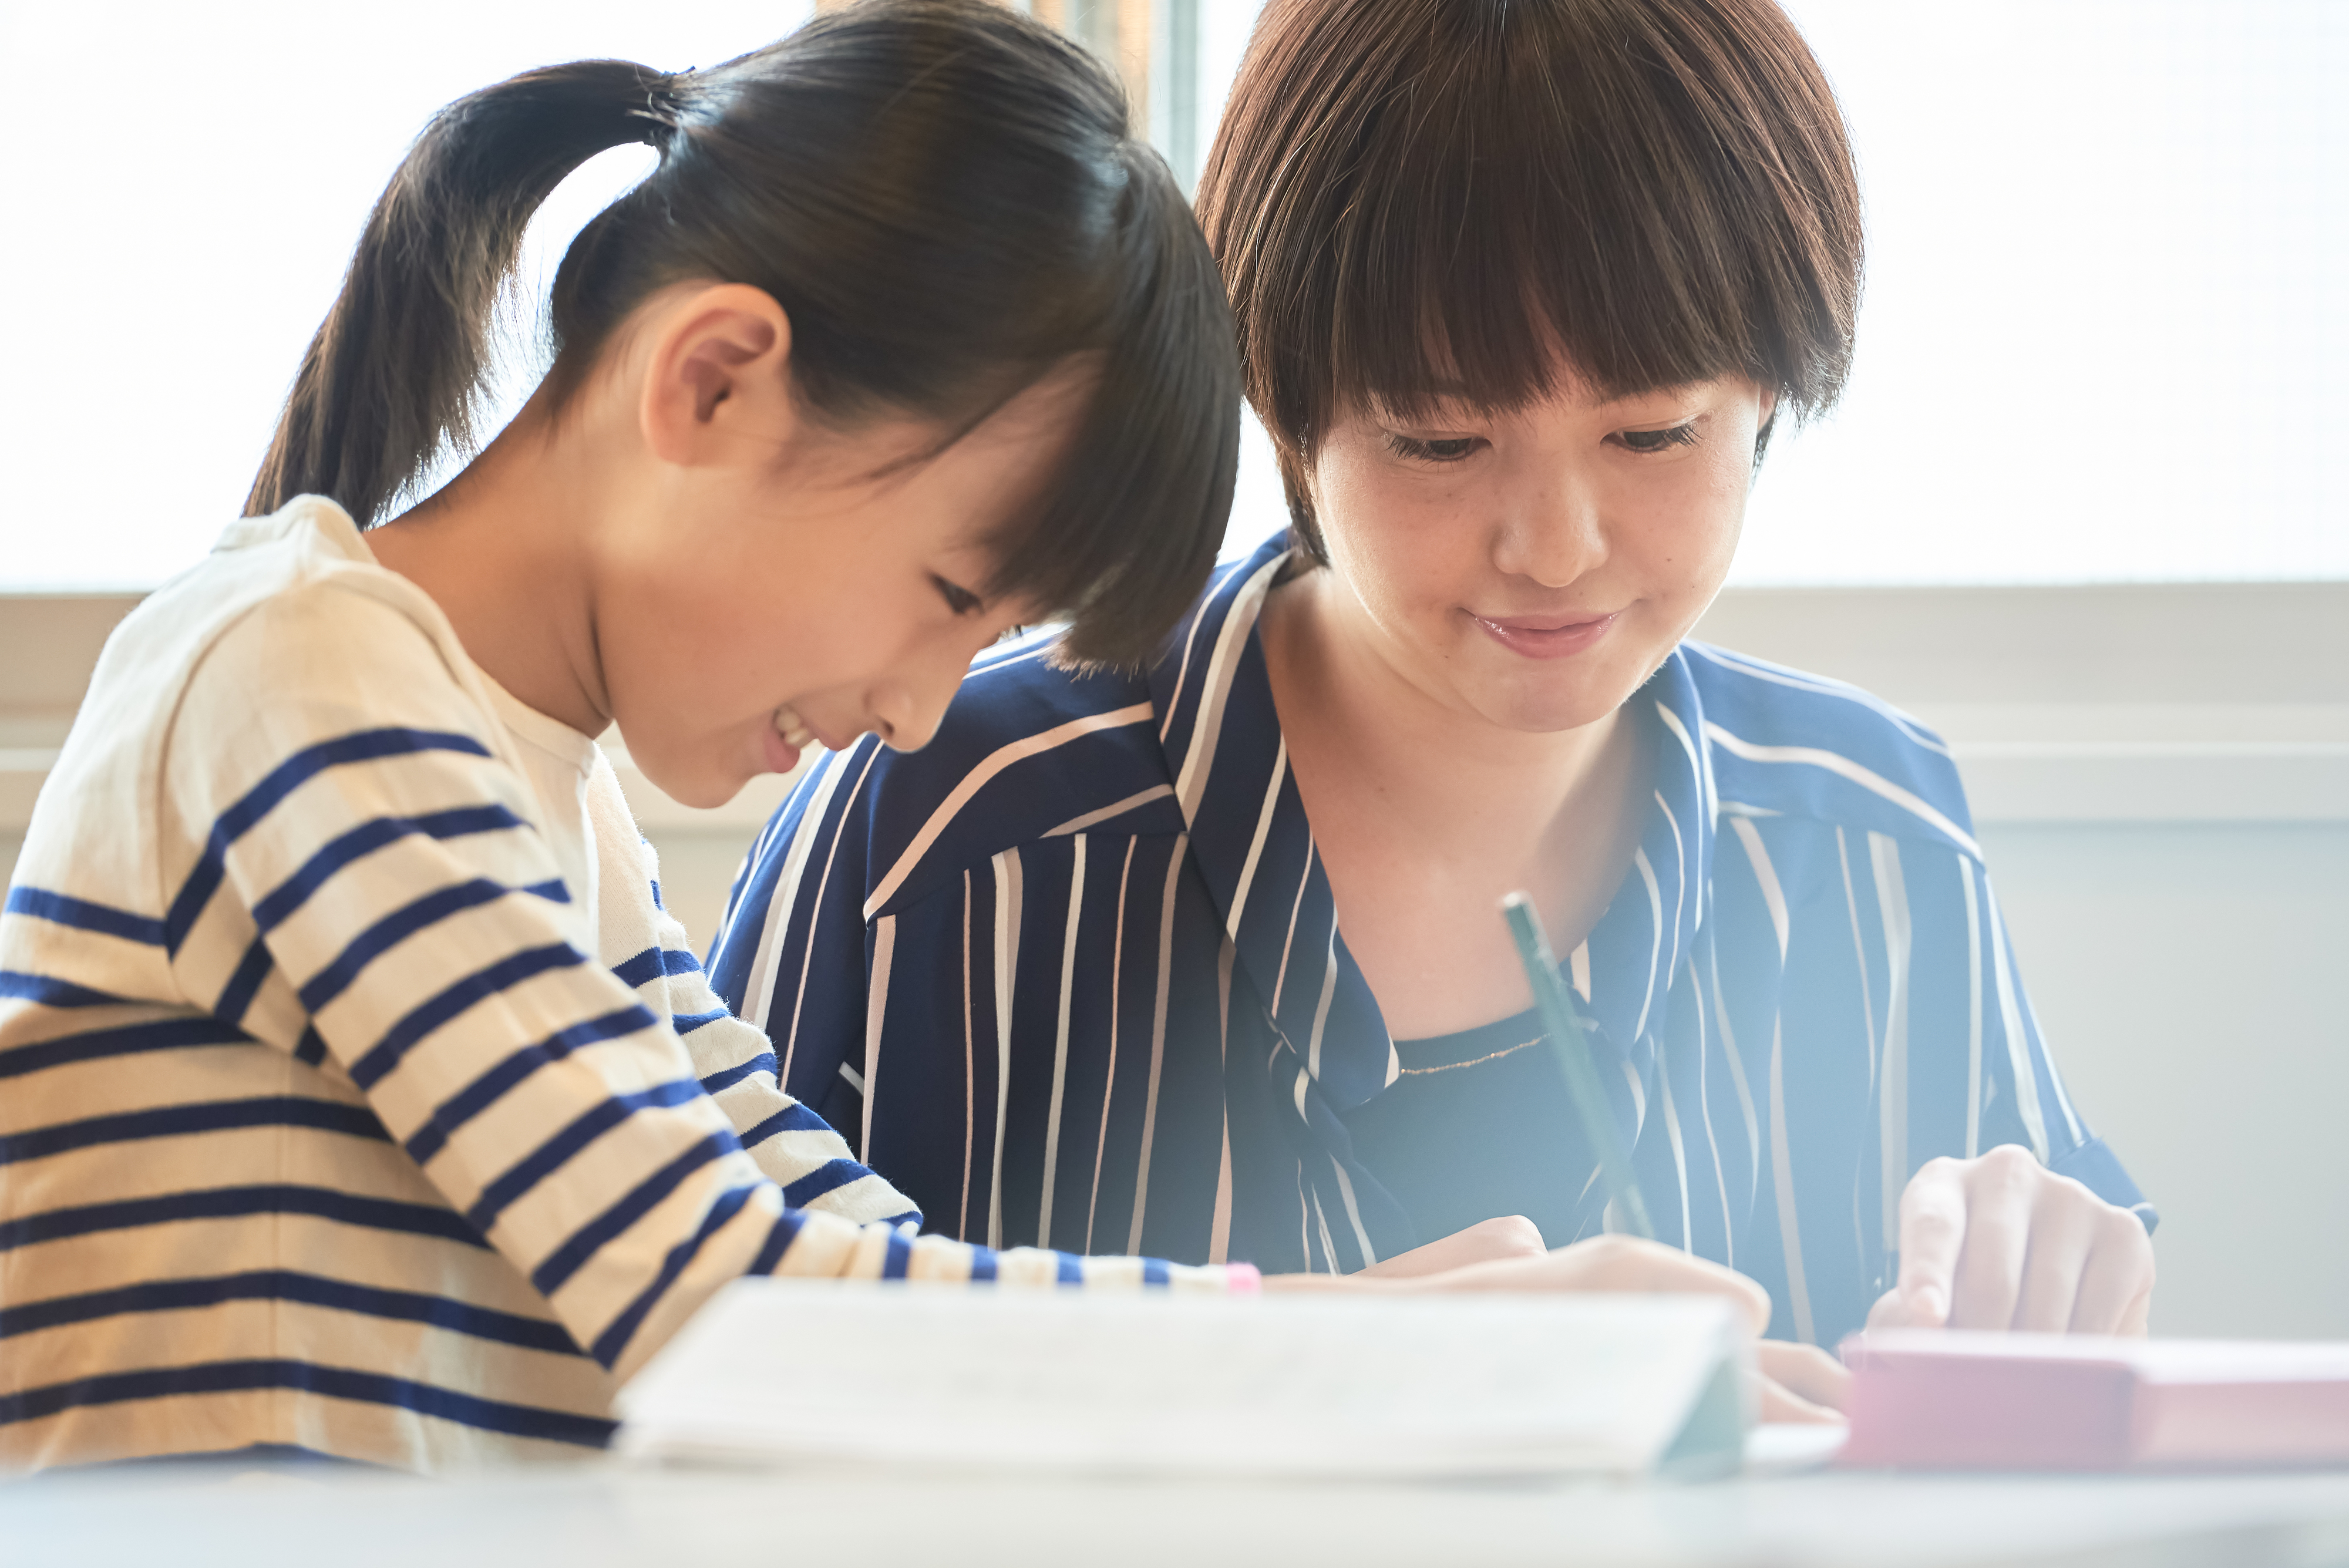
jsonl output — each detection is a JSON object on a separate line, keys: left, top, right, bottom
{"left": 162, "top": 587, "right": 1231, "bottom": 1375}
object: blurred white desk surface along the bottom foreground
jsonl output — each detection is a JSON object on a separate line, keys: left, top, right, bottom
{"left": 14, "top": 1465, "right": 2349, "bottom": 1568}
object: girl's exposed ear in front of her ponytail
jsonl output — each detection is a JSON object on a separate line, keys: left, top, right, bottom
{"left": 637, "top": 284, "right": 801, "bottom": 467}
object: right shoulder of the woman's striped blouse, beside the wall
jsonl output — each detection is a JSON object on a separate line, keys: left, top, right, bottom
{"left": 1654, "top": 641, "right": 1980, "bottom": 859}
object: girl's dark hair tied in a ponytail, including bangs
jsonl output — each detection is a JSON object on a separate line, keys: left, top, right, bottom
{"left": 247, "top": 0, "right": 1240, "bottom": 659}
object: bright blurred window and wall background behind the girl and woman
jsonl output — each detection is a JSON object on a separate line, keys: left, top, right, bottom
{"left": 0, "top": 0, "right": 2349, "bottom": 1338}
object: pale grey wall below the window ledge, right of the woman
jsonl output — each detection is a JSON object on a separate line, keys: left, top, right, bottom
{"left": 1983, "top": 822, "right": 2349, "bottom": 1338}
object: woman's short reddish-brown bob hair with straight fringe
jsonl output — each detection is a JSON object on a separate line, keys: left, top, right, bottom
{"left": 1198, "top": 0, "right": 1860, "bottom": 558}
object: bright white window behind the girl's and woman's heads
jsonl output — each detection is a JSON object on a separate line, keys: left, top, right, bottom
{"left": 0, "top": 0, "right": 2349, "bottom": 589}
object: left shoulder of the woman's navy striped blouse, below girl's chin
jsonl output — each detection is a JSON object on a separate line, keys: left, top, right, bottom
{"left": 794, "top": 631, "right": 1182, "bottom": 916}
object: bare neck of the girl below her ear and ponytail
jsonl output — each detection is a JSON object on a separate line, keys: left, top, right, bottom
{"left": 366, "top": 392, "right": 611, "bottom": 735}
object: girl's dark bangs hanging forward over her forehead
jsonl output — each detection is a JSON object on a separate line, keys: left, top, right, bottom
{"left": 989, "top": 148, "right": 1240, "bottom": 664}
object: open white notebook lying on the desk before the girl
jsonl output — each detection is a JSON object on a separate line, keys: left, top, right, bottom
{"left": 618, "top": 1279, "right": 1750, "bottom": 1476}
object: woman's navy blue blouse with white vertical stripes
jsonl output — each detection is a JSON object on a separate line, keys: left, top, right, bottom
{"left": 712, "top": 540, "right": 2138, "bottom": 1342}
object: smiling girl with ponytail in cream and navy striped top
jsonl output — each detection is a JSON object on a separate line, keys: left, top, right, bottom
{"left": 0, "top": 0, "right": 1759, "bottom": 1467}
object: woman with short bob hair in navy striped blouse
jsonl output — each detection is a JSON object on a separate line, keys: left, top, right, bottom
{"left": 714, "top": 0, "right": 2152, "bottom": 1401}
